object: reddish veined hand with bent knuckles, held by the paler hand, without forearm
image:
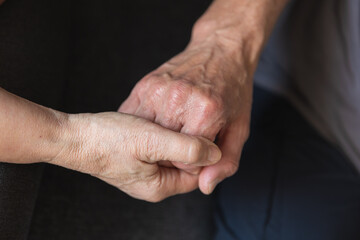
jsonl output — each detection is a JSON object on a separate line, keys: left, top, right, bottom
{"left": 119, "top": 39, "right": 254, "bottom": 194}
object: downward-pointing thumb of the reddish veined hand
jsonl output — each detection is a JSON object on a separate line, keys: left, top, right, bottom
{"left": 199, "top": 121, "right": 248, "bottom": 194}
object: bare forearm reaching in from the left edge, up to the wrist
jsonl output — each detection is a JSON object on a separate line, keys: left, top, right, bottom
{"left": 0, "top": 88, "right": 67, "bottom": 163}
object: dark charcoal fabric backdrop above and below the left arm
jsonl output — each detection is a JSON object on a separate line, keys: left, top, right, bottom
{"left": 0, "top": 0, "right": 214, "bottom": 240}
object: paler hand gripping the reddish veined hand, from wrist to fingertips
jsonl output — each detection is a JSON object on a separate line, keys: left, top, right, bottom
{"left": 50, "top": 112, "right": 221, "bottom": 202}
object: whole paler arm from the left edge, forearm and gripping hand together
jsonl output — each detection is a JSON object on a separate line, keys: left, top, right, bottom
{"left": 0, "top": 88, "right": 221, "bottom": 202}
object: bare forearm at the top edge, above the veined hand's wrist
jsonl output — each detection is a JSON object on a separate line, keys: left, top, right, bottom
{"left": 190, "top": 0, "right": 288, "bottom": 70}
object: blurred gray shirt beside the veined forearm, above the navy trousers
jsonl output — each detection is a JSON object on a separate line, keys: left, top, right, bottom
{"left": 255, "top": 0, "right": 360, "bottom": 171}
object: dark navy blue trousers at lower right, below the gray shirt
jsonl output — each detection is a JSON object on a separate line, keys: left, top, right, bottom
{"left": 215, "top": 88, "right": 360, "bottom": 240}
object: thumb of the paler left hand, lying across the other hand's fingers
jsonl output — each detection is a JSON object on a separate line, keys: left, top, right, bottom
{"left": 137, "top": 124, "right": 221, "bottom": 166}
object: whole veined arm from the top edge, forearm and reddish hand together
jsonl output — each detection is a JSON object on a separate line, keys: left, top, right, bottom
{"left": 119, "top": 0, "right": 287, "bottom": 194}
